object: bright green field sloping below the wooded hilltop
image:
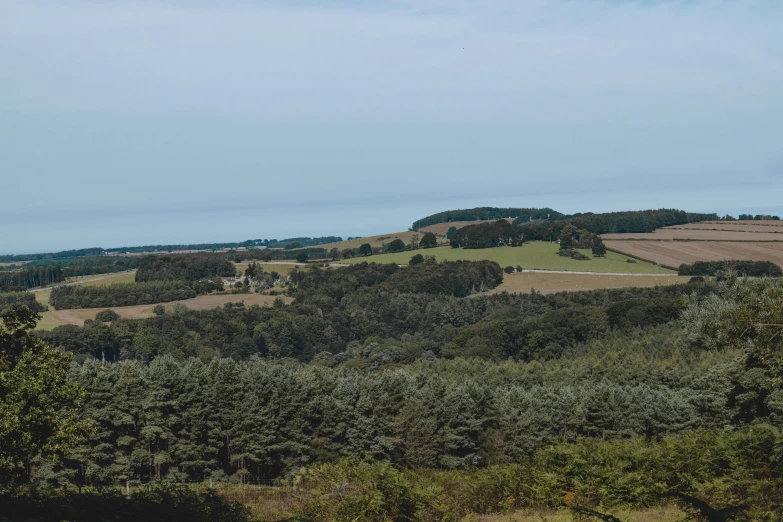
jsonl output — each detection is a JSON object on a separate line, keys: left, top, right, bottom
{"left": 342, "top": 241, "right": 676, "bottom": 274}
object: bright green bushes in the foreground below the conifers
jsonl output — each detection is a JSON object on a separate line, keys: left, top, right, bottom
{"left": 290, "top": 425, "right": 783, "bottom": 521}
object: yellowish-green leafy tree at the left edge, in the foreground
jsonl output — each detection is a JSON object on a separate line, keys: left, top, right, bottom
{"left": 0, "top": 308, "right": 91, "bottom": 484}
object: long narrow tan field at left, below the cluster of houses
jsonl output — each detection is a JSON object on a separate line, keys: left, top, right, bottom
{"left": 38, "top": 294, "right": 293, "bottom": 330}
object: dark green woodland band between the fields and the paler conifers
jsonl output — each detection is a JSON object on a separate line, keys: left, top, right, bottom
{"left": 39, "top": 260, "right": 696, "bottom": 361}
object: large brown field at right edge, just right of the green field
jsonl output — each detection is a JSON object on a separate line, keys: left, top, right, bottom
{"left": 604, "top": 238, "right": 783, "bottom": 268}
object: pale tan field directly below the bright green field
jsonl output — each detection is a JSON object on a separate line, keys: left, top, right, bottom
{"left": 487, "top": 272, "right": 690, "bottom": 294}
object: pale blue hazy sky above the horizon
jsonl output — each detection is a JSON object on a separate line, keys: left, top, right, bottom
{"left": 0, "top": 0, "right": 783, "bottom": 253}
